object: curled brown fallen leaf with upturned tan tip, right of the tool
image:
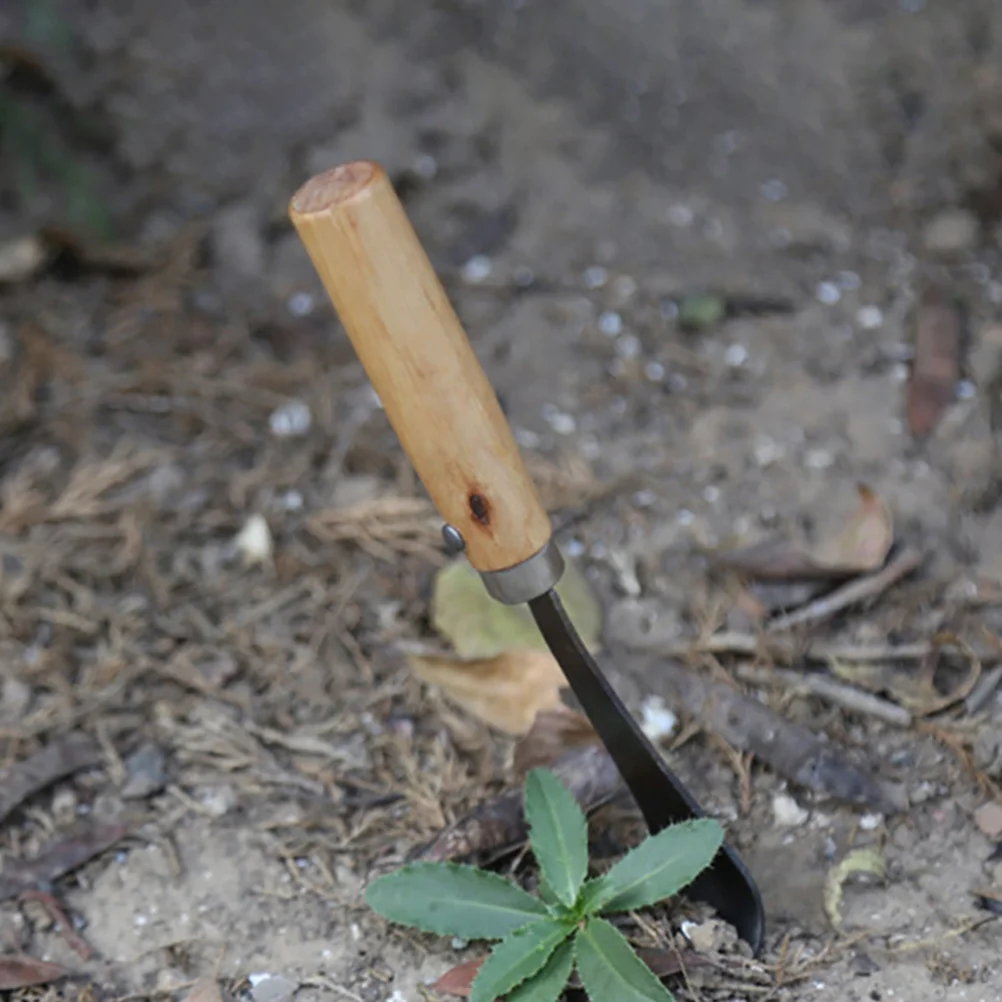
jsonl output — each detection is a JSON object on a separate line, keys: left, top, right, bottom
{"left": 715, "top": 484, "right": 894, "bottom": 581}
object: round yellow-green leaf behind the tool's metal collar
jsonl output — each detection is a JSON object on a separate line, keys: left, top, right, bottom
{"left": 432, "top": 557, "right": 602, "bottom": 657}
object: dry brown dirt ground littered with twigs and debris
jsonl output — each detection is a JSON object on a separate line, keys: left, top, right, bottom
{"left": 0, "top": 0, "right": 1002, "bottom": 1002}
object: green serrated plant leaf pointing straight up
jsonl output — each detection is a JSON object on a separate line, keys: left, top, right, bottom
{"left": 525, "top": 769, "right": 588, "bottom": 908}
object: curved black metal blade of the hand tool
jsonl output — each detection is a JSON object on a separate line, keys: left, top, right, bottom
{"left": 529, "top": 590, "right": 766, "bottom": 955}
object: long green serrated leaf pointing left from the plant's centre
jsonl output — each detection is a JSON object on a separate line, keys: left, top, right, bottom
{"left": 366, "top": 863, "right": 549, "bottom": 940}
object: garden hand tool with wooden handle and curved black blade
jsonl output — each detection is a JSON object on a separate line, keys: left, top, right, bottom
{"left": 290, "top": 160, "right": 765, "bottom": 953}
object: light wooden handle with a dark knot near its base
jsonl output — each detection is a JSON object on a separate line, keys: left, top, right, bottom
{"left": 289, "top": 160, "right": 551, "bottom": 572}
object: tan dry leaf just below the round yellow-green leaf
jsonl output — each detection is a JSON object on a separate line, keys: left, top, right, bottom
{"left": 408, "top": 647, "right": 567, "bottom": 734}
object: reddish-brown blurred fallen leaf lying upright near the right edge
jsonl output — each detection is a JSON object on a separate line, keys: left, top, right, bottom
{"left": 906, "top": 286, "right": 964, "bottom": 439}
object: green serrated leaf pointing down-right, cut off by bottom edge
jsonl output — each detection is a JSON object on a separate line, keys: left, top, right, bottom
{"left": 574, "top": 917, "right": 674, "bottom": 1002}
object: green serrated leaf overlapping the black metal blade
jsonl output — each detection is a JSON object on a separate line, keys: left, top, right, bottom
{"left": 583, "top": 818, "right": 723, "bottom": 913}
